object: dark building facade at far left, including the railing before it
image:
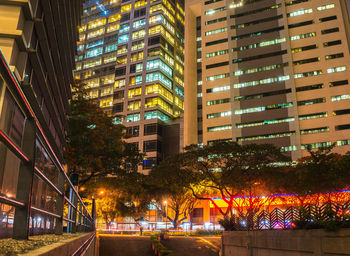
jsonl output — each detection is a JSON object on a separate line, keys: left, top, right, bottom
{"left": 0, "top": 0, "right": 93, "bottom": 239}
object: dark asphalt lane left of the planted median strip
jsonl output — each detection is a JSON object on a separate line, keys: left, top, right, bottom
{"left": 99, "top": 236, "right": 154, "bottom": 256}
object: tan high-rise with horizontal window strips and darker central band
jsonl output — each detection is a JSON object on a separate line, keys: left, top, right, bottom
{"left": 184, "top": 0, "right": 350, "bottom": 159}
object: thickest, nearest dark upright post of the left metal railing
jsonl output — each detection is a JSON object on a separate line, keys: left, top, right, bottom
{"left": 12, "top": 117, "right": 36, "bottom": 239}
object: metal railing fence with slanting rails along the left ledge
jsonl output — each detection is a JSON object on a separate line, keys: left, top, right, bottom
{"left": 0, "top": 51, "right": 94, "bottom": 239}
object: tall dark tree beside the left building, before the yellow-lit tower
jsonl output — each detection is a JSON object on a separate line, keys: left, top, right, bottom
{"left": 65, "top": 83, "right": 142, "bottom": 185}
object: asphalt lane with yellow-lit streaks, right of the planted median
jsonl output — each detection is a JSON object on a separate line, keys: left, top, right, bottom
{"left": 162, "top": 236, "right": 221, "bottom": 256}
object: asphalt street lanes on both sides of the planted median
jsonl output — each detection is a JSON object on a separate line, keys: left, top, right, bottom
{"left": 99, "top": 235, "right": 221, "bottom": 256}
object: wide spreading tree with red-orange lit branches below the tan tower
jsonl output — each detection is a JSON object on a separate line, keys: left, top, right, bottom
{"left": 184, "top": 142, "right": 289, "bottom": 225}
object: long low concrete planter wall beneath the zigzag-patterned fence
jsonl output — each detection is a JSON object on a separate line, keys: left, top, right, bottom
{"left": 221, "top": 229, "right": 350, "bottom": 256}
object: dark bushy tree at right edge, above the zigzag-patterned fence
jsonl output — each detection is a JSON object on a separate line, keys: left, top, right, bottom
{"left": 280, "top": 145, "right": 349, "bottom": 206}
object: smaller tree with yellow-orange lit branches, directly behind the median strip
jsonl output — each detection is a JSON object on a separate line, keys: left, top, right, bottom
{"left": 148, "top": 155, "right": 197, "bottom": 229}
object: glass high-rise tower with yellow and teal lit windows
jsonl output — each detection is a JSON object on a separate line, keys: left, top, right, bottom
{"left": 75, "top": 0, "right": 184, "bottom": 170}
